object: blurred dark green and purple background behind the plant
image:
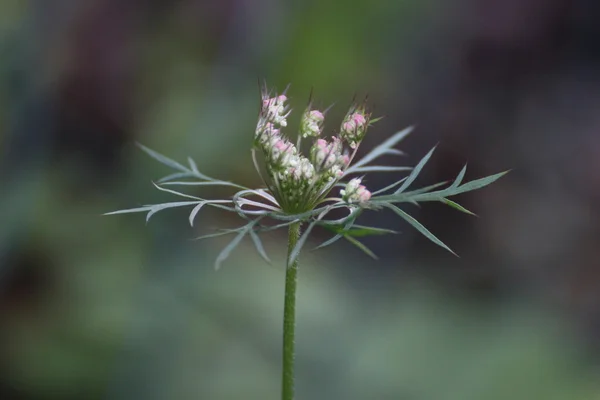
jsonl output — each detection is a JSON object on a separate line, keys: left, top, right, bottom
{"left": 0, "top": 0, "right": 600, "bottom": 400}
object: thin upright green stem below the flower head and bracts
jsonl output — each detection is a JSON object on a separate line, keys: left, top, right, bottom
{"left": 281, "top": 222, "right": 300, "bottom": 400}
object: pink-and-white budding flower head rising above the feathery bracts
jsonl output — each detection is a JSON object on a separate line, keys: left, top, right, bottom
{"left": 254, "top": 87, "right": 369, "bottom": 212}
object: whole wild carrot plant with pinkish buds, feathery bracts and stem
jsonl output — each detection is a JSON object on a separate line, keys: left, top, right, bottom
{"left": 108, "top": 83, "right": 506, "bottom": 400}
